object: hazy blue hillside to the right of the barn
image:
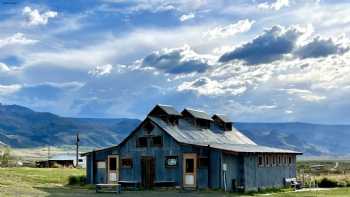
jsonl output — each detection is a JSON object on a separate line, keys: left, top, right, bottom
{"left": 235, "top": 122, "right": 350, "bottom": 155}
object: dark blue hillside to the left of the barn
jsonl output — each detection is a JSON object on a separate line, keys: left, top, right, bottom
{"left": 0, "top": 105, "right": 140, "bottom": 148}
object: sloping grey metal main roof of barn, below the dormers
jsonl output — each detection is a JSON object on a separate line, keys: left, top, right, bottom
{"left": 148, "top": 117, "right": 301, "bottom": 154}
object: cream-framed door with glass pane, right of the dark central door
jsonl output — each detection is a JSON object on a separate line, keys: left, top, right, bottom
{"left": 183, "top": 153, "right": 197, "bottom": 187}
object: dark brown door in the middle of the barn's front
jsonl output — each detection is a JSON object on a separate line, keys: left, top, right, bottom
{"left": 141, "top": 157, "right": 155, "bottom": 189}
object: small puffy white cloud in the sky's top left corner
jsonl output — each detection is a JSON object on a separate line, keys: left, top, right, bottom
{"left": 22, "top": 6, "right": 57, "bottom": 26}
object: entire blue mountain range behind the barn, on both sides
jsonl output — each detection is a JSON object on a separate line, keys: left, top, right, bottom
{"left": 0, "top": 104, "right": 350, "bottom": 155}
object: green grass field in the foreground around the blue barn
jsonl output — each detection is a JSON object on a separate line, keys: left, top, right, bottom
{"left": 0, "top": 168, "right": 350, "bottom": 197}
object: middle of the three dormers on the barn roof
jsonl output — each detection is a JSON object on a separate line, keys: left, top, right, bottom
{"left": 181, "top": 108, "right": 213, "bottom": 129}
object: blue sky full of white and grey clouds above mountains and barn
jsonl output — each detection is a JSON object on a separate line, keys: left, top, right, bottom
{"left": 0, "top": 0, "right": 350, "bottom": 124}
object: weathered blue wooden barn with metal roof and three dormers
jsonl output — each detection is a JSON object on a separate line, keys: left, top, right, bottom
{"left": 83, "top": 105, "right": 301, "bottom": 191}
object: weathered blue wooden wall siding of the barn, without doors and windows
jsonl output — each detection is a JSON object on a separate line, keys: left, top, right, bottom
{"left": 86, "top": 123, "right": 296, "bottom": 191}
